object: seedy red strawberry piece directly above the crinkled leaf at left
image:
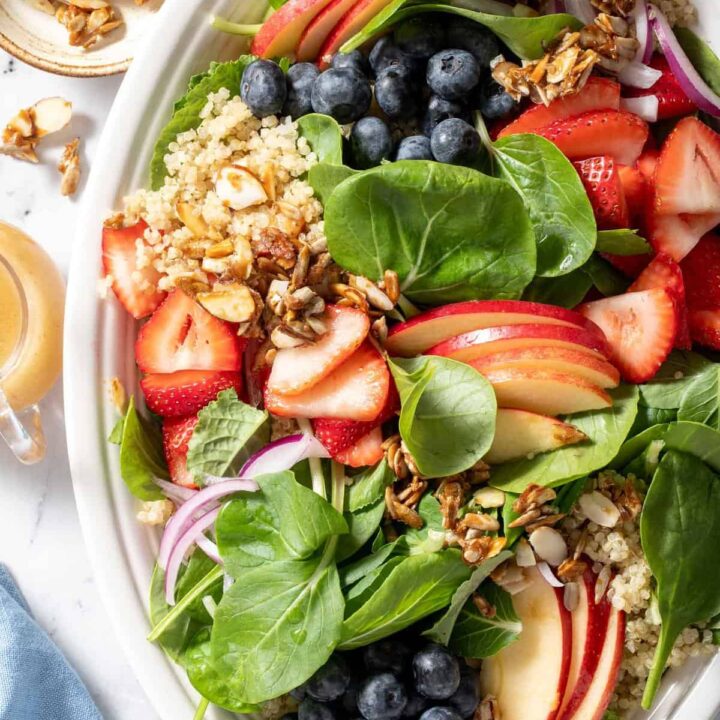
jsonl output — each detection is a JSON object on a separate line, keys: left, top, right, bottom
{"left": 140, "top": 370, "right": 243, "bottom": 417}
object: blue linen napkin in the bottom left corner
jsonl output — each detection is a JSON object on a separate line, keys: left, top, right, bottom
{"left": 0, "top": 565, "right": 102, "bottom": 720}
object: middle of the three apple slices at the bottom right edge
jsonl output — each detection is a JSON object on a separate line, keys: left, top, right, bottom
{"left": 558, "top": 568, "right": 612, "bottom": 720}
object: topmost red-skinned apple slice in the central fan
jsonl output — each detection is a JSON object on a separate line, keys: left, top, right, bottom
{"left": 387, "top": 300, "right": 602, "bottom": 357}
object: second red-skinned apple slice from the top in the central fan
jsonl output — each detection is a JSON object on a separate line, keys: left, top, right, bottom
{"left": 425, "top": 324, "right": 607, "bottom": 362}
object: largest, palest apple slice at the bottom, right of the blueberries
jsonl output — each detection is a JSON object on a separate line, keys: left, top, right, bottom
{"left": 480, "top": 567, "right": 572, "bottom": 720}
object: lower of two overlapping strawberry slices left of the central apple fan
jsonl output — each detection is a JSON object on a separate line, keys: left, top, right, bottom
{"left": 265, "top": 342, "right": 390, "bottom": 421}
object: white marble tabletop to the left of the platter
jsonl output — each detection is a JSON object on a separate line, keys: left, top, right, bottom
{"left": 0, "top": 51, "right": 158, "bottom": 720}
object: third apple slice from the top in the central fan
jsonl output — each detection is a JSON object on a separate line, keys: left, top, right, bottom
{"left": 472, "top": 347, "right": 620, "bottom": 388}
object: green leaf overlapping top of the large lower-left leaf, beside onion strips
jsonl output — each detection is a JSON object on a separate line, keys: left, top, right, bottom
{"left": 215, "top": 472, "right": 348, "bottom": 577}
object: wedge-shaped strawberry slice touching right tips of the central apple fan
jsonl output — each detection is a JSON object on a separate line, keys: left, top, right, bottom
{"left": 577, "top": 288, "right": 678, "bottom": 383}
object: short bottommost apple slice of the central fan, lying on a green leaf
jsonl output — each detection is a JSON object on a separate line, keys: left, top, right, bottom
{"left": 483, "top": 408, "right": 587, "bottom": 465}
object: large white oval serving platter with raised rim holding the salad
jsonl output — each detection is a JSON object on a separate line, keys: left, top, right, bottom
{"left": 65, "top": 0, "right": 720, "bottom": 720}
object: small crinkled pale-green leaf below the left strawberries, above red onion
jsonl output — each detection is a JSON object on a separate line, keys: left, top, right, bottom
{"left": 187, "top": 390, "right": 270, "bottom": 480}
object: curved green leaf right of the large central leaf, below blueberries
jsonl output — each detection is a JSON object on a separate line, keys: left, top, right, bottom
{"left": 491, "top": 134, "right": 597, "bottom": 277}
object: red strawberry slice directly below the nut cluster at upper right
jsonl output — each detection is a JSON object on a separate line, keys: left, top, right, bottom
{"left": 498, "top": 77, "right": 620, "bottom": 140}
